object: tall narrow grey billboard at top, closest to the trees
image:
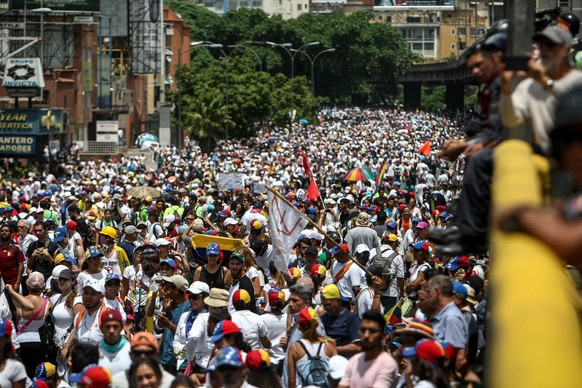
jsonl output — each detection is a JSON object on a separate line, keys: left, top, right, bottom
{"left": 129, "top": 0, "right": 163, "bottom": 74}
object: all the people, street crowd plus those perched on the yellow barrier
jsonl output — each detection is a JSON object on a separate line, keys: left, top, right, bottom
{"left": 0, "top": 12, "right": 582, "bottom": 388}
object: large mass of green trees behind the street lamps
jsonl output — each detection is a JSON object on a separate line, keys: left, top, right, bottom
{"left": 165, "top": 0, "right": 418, "bottom": 136}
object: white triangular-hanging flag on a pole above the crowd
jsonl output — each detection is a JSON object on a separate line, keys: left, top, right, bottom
{"left": 267, "top": 190, "right": 307, "bottom": 274}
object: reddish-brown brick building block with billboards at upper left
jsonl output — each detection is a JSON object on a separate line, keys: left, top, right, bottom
{"left": 0, "top": 0, "right": 190, "bottom": 156}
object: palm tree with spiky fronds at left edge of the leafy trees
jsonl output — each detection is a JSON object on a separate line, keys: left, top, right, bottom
{"left": 182, "top": 92, "right": 233, "bottom": 152}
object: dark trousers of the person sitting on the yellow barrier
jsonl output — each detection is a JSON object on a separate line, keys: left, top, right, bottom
{"left": 456, "top": 148, "right": 494, "bottom": 244}
